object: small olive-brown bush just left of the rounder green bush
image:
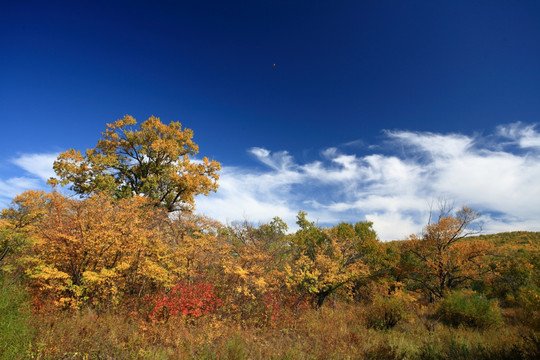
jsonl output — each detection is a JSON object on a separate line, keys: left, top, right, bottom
{"left": 366, "top": 296, "right": 407, "bottom": 330}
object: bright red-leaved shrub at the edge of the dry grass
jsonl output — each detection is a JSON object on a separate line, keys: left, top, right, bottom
{"left": 148, "top": 282, "right": 222, "bottom": 321}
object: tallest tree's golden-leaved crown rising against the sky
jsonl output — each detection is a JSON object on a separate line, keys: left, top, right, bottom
{"left": 50, "top": 115, "right": 220, "bottom": 211}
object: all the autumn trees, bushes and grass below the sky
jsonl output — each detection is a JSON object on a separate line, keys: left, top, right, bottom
{"left": 0, "top": 117, "right": 540, "bottom": 359}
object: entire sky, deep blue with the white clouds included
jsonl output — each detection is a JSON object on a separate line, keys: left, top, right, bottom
{"left": 0, "top": 0, "right": 540, "bottom": 240}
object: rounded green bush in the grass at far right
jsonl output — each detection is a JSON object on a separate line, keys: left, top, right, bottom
{"left": 437, "top": 290, "right": 502, "bottom": 328}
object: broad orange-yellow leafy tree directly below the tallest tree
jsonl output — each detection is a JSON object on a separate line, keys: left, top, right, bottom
{"left": 4, "top": 192, "right": 176, "bottom": 308}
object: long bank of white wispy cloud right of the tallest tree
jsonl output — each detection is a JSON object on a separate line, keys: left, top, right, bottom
{"left": 198, "top": 123, "right": 540, "bottom": 240}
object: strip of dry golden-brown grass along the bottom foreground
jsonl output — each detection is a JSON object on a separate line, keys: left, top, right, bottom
{"left": 22, "top": 304, "right": 540, "bottom": 359}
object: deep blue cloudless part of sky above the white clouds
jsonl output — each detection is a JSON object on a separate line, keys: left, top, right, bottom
{"left": 0, "top": 0, "right": 540, "bottom": 239}
